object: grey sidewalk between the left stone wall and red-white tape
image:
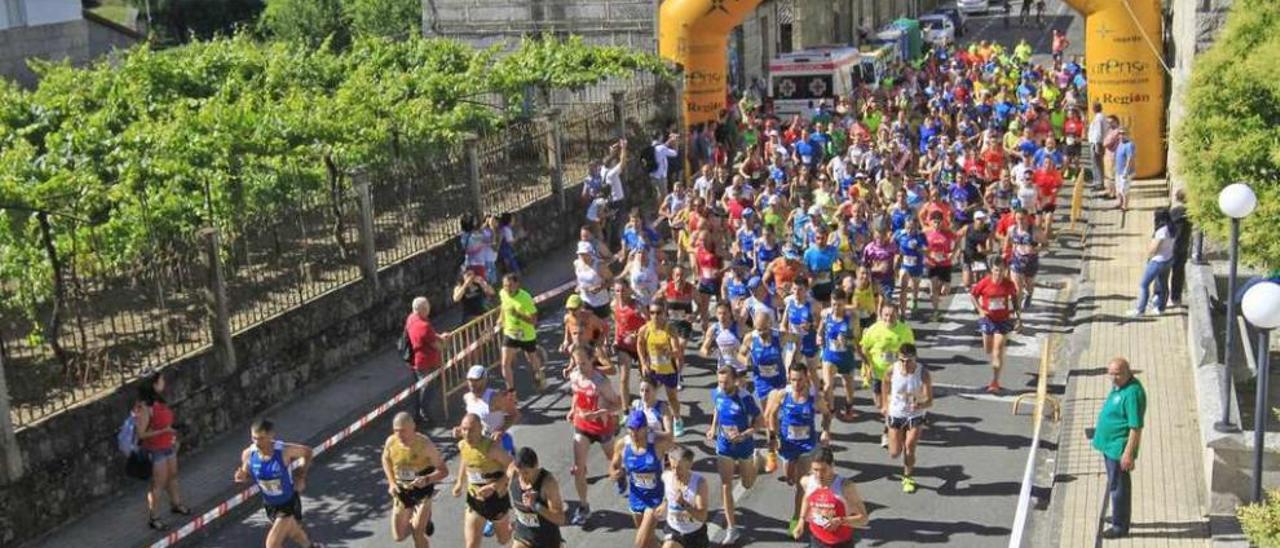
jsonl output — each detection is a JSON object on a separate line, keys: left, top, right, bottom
{"left": 27, "top": 247, "right": 572, "bottom": 548}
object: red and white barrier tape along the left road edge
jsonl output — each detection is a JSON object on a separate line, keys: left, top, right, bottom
{"left": 151, "top": 282, "right": 576, "bottom": 548}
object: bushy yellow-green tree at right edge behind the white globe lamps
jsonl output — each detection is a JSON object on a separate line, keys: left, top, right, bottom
{"left": 1174, "top": 0, "right": 1280, "bottom": 268}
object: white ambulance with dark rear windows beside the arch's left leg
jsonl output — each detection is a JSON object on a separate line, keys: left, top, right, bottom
{"left": 769, "top": 46, "right": 860, "bottom": 118}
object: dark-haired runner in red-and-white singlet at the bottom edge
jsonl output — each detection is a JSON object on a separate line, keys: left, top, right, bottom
{"left": 791, "top": 447, "right": 869, "bottom": 548}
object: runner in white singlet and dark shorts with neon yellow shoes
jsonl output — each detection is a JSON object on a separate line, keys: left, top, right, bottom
{"left": 881, "top": 343, "right": 933, "bottom": 493}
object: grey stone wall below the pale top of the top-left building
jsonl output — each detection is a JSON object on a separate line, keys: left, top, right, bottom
{"left": 0, "top": 13, "right": 137, "bottom": 87}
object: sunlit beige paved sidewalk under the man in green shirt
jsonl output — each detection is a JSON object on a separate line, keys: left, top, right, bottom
{"left": 1055, "top": 179, "right": 1210, "bottom": 547}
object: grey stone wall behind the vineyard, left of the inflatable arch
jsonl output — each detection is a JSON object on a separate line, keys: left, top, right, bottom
{"left": 422, "top": 0, "right": 658, "bottom": 51}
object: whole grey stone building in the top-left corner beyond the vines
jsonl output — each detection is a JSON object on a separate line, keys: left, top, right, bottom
{"left": 0, "top": 0, "right": 141, "bottom": 87}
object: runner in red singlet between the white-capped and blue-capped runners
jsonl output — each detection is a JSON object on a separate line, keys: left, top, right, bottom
{"left": 568, "top": 346, "right": 622, "bottom": 526}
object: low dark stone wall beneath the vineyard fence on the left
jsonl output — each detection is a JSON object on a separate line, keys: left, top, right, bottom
{"left": 0, "top": 96, "right": 664, "bottom": 547}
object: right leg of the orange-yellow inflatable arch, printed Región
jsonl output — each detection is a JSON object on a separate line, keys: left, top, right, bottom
{"left": 1066, "top": 0, "right": 1165, "bottom": 177}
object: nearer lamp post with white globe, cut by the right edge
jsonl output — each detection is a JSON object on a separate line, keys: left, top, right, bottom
{"left": 1240, "top": 282, "right": 1280, "bottom": 502}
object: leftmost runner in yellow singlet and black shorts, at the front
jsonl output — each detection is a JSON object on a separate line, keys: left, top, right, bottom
{"left": 383, "top": 411, "right": 449, "bottom": 548}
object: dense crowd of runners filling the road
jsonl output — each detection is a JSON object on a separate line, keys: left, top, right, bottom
{"left": 236, "top": 36, "right": 1087, "bottom": 548}
